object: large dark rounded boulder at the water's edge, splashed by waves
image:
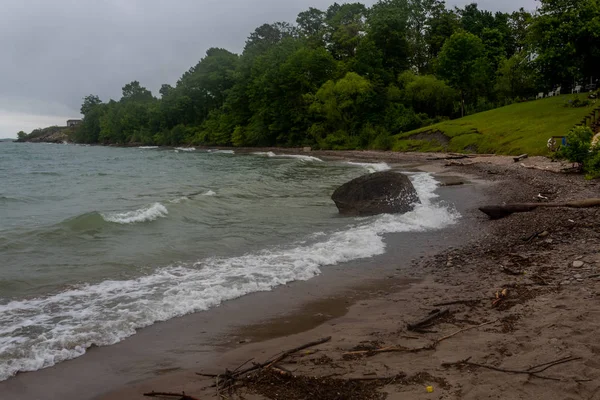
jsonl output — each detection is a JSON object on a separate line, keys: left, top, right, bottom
{"left": 331, "top": 171, "right": 420, "bottom": 215}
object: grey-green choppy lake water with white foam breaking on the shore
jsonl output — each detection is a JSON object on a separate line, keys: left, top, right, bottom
{"left": 0, "top": 142, "right": 459, "bottom": 380}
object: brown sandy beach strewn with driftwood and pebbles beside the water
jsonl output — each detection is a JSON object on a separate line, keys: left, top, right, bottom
{"left": 0, "top": 152, "right": 600, "bottom": 400}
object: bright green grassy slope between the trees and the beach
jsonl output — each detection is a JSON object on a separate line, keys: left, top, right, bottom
{"left": 393, "top": 95, "right": 598, "bottom": 155}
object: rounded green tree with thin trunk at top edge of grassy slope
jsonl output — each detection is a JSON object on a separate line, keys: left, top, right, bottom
{"left": 438, "top": 32, "right": 486, "bottom": 116}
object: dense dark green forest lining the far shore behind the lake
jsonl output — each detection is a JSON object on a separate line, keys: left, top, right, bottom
{"left": 74, "top": 0, "right": 600, "bottom": 149}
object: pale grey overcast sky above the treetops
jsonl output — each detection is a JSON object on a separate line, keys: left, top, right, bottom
{"left": 0, "top": 0, "right": 536, "bottom": 138}
